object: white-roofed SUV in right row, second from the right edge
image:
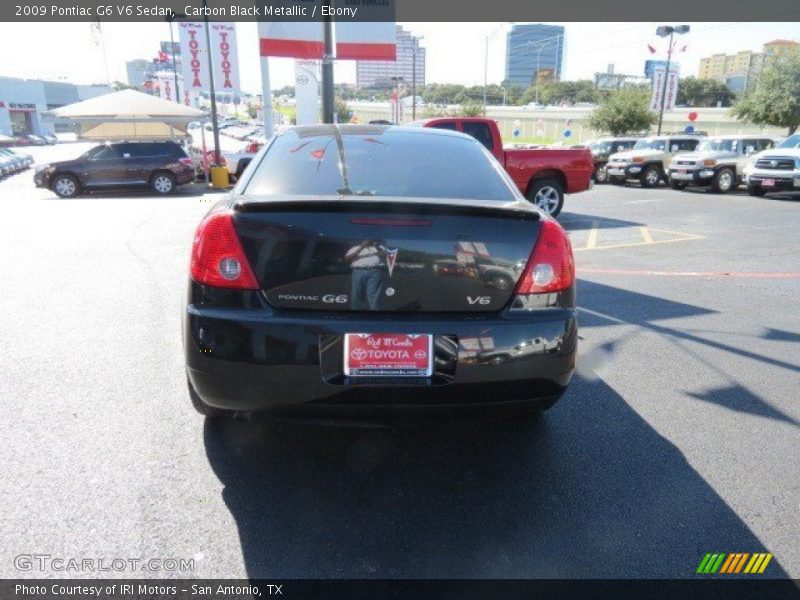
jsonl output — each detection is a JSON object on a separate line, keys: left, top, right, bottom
{"left": 669, "top": 135, "right": 775, "bottom": 194}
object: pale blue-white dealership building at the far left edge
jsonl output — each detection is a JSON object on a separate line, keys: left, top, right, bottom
{"left": 0, "top": 77, "right": 113, "bottom": 136}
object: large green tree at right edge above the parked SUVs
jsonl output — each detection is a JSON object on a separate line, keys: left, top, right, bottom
{"left": 731, "top": 51, "right": 800, "bottom": 135}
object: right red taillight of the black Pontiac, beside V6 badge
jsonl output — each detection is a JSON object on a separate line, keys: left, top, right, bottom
{"left": 516, "top": 220, "right": 575, "bottom": 294}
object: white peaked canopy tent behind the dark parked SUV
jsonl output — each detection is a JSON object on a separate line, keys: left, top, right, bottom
{"left": 50, "top": 90, "right": 206, "bottom": 141}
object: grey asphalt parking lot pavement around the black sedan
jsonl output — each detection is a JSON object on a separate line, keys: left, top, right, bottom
{"left": 0, "top": 145, "right": 800, "bottom": 578}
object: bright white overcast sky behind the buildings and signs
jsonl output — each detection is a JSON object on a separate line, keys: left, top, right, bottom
{"left": 0, "top": 22, "right": 800, "bottom": 92}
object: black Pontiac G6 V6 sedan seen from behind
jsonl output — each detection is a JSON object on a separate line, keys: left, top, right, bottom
{"left": 183, "top": 125, "right": 577, "bottom": 417}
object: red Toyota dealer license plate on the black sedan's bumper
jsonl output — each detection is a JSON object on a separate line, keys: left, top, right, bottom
{"left": 344, "top": 333, "right": 433, "bottom": 377}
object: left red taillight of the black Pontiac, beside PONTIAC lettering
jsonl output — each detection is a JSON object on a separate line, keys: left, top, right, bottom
{"left": 191, "top": 212, "right": 258, "bottom": 290}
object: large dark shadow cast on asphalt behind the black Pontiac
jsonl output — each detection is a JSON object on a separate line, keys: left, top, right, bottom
{"left": 204, "top": 377, "right": 786, "bottom": 578}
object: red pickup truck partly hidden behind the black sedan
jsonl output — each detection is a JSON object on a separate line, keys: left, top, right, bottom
{"left": 415, "top": 117, "right": 594, "bottom": 217}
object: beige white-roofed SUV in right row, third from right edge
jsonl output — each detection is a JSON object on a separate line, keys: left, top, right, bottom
{"left": 606, "top": 133, "right": 702, "bottom": 187}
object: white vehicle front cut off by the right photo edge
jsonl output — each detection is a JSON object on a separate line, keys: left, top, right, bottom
{"left": 745, "top": 133, "right": 800, "bottom": 196}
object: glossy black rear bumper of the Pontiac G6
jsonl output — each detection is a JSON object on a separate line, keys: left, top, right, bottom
{"left": 183, "top": 305, "right": 577, "bottom": 416}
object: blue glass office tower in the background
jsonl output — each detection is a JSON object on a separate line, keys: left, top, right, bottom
{"left": 505, "top": 23, "right": 565, "bottom": 88}
